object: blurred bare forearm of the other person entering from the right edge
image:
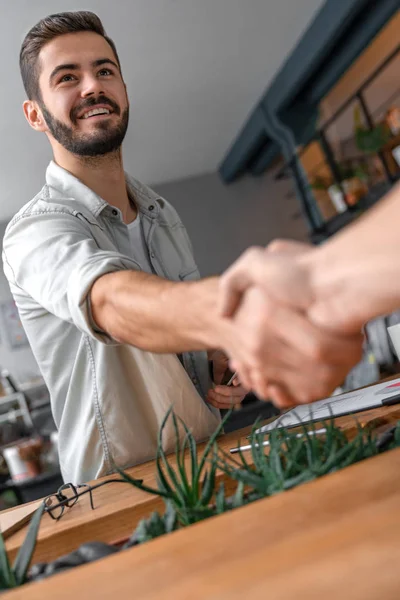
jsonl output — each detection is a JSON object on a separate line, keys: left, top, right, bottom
{"left": 306, "top": 180, "right": 400, "bottom": 332}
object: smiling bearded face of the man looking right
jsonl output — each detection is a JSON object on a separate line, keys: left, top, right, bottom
{"left": 38, "top": 32, "right": 129, "bottom": 156}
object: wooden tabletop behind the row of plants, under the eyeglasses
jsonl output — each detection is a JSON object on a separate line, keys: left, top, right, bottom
{"left": 0, "top": 398, "right": 400, "bottom": 563}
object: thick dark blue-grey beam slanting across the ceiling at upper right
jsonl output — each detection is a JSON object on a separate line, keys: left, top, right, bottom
{"left": 220, "top": 0, "right": 399, "bottom": 183}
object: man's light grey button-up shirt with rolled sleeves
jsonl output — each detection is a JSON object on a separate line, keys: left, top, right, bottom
{"left": 3, "top": 162, "right": 219, "bottom": 483}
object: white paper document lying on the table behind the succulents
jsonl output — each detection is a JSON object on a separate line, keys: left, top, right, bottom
{"left": 257, "top": 378, "right": 400, "bottom": 432}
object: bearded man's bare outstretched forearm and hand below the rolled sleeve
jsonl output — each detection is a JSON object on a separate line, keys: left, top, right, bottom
{"left": 91, "top": 271, "right": 361, "bottom": 408}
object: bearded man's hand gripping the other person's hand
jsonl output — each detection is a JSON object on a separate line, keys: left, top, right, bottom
{"left": 225, "top": 286, "right": 362, "bottom": 407}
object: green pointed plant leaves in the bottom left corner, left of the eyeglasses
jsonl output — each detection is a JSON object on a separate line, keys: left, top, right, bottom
{"left": 0, "top": 503, "right": 44, "bottom": 591}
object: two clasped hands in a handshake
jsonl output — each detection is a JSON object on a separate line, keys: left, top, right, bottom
{"left": 218, "top": 241, "right": 368, "bottom": 408}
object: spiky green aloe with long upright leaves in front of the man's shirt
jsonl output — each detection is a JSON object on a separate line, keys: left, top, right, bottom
{"left": 116, "top": 407, "right": 230, "bottom": 525}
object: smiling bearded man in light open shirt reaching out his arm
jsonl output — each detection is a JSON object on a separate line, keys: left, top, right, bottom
{"left": 3, "top": 12, "right": 245, "bottom": 483}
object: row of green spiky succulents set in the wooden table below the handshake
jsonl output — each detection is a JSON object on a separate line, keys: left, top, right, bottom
{"left": 118, "top": 408, "right": 400, "bottom": 542}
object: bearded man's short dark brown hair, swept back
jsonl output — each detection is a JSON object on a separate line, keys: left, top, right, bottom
{"left": 19, "top": 10, "right": 120, "bottom": 100}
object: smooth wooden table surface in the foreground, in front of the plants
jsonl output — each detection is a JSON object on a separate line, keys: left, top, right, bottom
{"left": 7, "top": 449, "right": 400, "bottom": 600}
